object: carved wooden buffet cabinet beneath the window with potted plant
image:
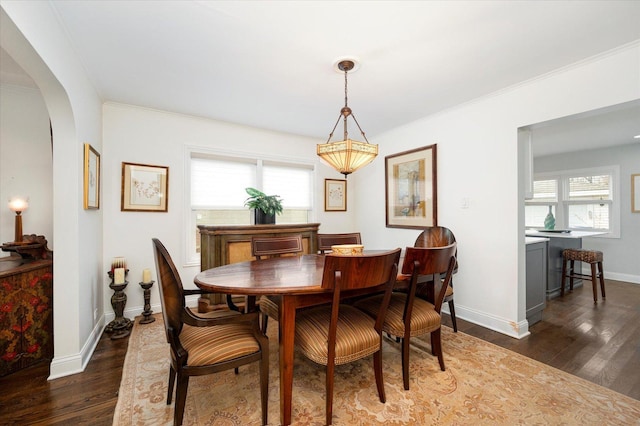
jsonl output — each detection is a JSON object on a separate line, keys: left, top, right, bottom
{"left": 198, "top": 223, "right": 320, "bottom": 312}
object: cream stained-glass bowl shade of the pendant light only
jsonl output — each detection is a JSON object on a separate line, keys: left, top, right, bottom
{"left": 318, "top": 139, "right": 378, "bottom": 176}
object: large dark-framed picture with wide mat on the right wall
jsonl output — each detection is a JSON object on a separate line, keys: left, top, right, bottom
{"left": 384, "top": 144, "right": 438, "bottom": 229}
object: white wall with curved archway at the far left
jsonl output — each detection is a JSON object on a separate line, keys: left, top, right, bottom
{"left": 0, "top": 2, "right": 104, "bottom": 378}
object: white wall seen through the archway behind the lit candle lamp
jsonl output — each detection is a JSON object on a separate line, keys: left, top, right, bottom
{"left": 0, "top": 85, "right": 54, "bottom": 248}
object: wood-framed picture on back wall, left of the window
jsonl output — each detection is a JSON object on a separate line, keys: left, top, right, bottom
{"left": 120, "top": 162, "right": 169, "bottom": 212}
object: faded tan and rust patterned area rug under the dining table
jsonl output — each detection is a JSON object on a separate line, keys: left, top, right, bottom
{"left": 113, "top": 315, "right": 640, "bottom": 426}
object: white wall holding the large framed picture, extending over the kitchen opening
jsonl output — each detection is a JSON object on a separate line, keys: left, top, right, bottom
{"left": 355, "top": 43, "right": 640, "bottom": 336}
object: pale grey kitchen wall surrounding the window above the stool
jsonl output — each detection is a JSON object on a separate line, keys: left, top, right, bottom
{"left": 534, "top": 143, "right": 640, "bottom": 284}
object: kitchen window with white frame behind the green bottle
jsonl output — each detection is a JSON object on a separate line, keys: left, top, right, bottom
{"left": 525, "top": 166, "right": 620, "bottom": 237}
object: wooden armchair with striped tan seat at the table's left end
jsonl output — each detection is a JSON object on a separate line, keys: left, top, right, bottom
{"left": 152, "top": 238, "right": 269, "bottom": 425}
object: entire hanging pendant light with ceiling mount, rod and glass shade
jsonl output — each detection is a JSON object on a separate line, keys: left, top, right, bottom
{"left": 318, "top": 60, "right": 378, "bottom": 178}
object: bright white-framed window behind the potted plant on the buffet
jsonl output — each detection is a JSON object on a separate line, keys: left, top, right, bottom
{"left": 187, "top": 151, "right": 314, "bottom": 264}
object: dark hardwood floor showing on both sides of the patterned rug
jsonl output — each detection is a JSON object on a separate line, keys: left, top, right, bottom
{"left": 0, "top": 280, "right": 640, "bottom": 426}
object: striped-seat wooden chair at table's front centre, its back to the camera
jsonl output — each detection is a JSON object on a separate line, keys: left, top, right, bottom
{"left": 295, "top": 248, "right": 400, "bottom": 425}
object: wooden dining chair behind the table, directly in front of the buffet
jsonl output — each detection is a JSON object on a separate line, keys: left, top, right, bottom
{"left": 247, "top": 234, "right": 304, "bottom": 334}
